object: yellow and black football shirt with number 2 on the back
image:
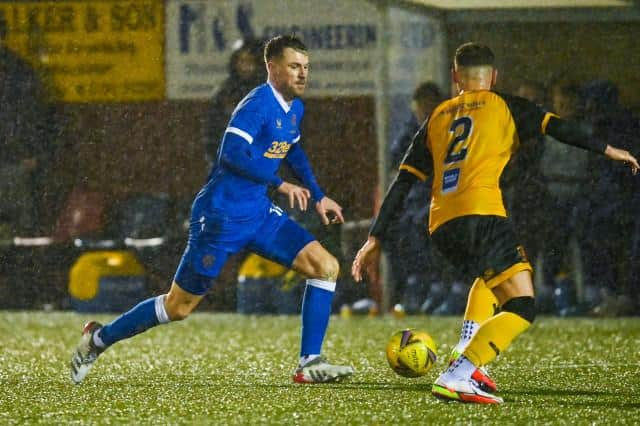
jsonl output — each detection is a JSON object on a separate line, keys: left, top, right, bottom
{"left": 400, "top": 90, "right": 554, "bottom": 233}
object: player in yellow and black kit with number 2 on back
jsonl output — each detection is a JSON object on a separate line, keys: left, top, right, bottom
{"left": 352, "top": 43, "right": 639, "bottom": 404}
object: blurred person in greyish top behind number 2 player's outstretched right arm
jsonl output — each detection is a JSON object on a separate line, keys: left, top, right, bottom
{"left": 538, "top": 81, "right": 588, "bottom": 315}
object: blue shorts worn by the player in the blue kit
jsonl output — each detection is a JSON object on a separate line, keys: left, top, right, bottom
{"left": 174, "top": 204, "right": 315, "bottom": 296}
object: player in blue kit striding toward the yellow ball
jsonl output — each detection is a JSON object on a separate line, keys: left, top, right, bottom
{"left": 70, "top": 36, "right": 354, "bottom": 383}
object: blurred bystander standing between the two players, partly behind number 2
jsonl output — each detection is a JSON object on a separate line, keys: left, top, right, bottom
{"left": 385, "top": 82, "right": 464, "bottom": 313}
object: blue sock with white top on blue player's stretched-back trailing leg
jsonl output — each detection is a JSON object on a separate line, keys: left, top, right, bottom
{"left": 98, "top": 294, "right": 169, "bottom": 347}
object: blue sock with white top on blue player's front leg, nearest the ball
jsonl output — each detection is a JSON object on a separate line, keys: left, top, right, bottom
{"left": 300, "top": 279, "right": 336, "bottom": 356}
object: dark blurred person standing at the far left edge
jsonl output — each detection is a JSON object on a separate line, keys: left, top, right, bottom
{"left": 0, "top": 19, "right": 54, "bottom": 238}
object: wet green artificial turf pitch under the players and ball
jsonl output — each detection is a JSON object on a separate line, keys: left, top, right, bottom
{"left": 0, "top": 312, "right": 640, "bottom": 425}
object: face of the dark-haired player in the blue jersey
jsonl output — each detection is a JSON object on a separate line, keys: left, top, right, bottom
{"left": 269, "top": 47, "right": 309, "bottom": 101}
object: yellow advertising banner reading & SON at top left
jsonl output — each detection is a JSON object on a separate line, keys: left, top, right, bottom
{"left": 0, "top": 0, "right": 165, "bottom": 102}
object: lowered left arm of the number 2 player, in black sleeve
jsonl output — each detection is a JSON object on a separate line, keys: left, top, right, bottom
{"left": 351, "top": 122, "right": 433, "bottom": 282}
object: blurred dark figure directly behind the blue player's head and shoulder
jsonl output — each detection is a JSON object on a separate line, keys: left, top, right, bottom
{"left": 204, "top": 39, "right": 267, "bottom": 166}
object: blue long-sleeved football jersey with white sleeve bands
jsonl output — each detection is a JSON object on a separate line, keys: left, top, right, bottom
{"left": 194, "top": 83, "right": 304, "bottom": 219}
